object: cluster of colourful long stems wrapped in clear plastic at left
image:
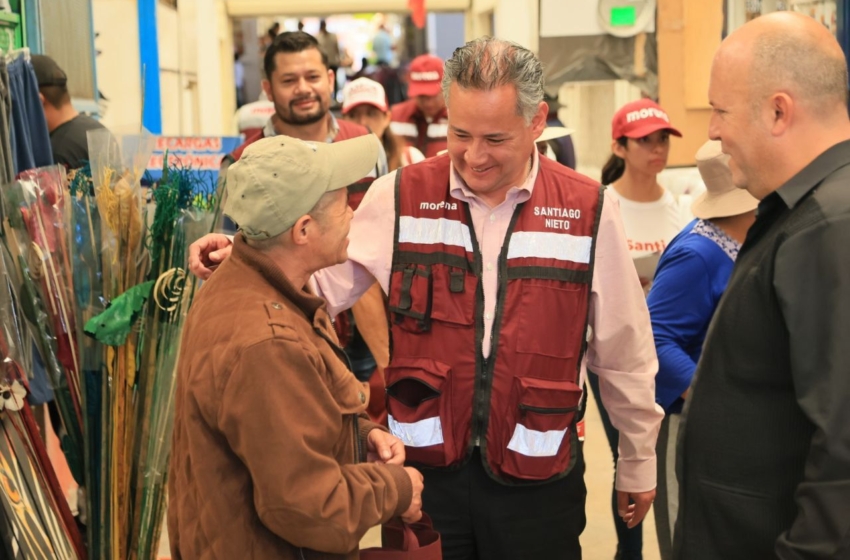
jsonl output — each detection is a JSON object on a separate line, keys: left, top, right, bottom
{"left": 0, "top": 131, "right": 215, "bottom": 560}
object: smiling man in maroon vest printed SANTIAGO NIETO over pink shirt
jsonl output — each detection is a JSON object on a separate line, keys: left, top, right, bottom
{"left": 190, "top": 38, "right": 663, "bottom": 560}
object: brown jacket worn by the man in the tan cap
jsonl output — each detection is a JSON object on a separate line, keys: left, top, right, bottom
{"left": 168, "top": 235, "right": 412, "bottom": 560}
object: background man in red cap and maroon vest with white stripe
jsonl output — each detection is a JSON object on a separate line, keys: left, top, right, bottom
{"left": 390, "top": 54, "right": 448, "bottom": 157}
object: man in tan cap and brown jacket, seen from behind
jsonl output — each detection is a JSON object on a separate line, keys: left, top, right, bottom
{"left": 168, "top": 135, "right": 422, "bottom": 560}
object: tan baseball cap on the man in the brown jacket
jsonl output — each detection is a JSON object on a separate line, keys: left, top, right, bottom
{"left": 224, "top": 134, "right": 379, "bottom": 239}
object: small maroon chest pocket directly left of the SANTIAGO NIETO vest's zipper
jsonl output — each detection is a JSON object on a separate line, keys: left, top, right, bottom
{"left": 431, "top": 265, "right": 478, "bottom": 327}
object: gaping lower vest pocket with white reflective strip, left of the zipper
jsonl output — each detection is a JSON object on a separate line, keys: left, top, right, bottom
{"left": 385, "top": 358, "right": 456, "bottom": 467}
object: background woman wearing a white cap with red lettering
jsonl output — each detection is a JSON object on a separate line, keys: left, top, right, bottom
{"left": 342, "top": 78, "right": 425, "bottom": 171}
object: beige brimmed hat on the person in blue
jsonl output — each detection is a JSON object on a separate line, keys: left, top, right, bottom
{"left": 691, "top": 140, "right": 759, "bottom": 220}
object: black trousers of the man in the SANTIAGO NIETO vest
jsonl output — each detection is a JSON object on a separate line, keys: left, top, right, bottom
{"left": 422, "top": 446, "right": 587, "bottom": 560}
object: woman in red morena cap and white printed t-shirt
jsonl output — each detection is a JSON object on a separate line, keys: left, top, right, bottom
{"left": 587, "top": 99, "right": 692, "bottom": 560}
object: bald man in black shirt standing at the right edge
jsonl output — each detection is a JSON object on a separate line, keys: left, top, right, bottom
{"left": 674, "top": 12, "right": 850, "bottom": 560}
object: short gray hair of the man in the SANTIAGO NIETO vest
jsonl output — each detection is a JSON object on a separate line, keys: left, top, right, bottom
{"left": 443, "top": 37, "right": 543, "bottom": 124}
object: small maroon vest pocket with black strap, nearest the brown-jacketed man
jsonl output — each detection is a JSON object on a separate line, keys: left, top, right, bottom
{"left": 387, "top": 264, "right": 431, "bottom": 333}
